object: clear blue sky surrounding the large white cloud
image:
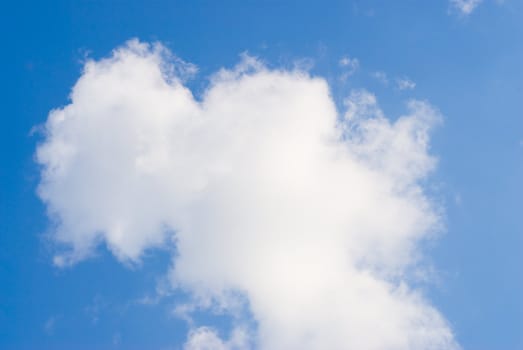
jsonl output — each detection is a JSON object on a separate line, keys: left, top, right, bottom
{"left": 0, "top": 0, "right": 523, "bottom": 350}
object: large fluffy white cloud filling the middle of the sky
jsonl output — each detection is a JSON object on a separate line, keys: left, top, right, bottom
{"left": 36, "top": 41, "right": 459, "bottom": 350}
